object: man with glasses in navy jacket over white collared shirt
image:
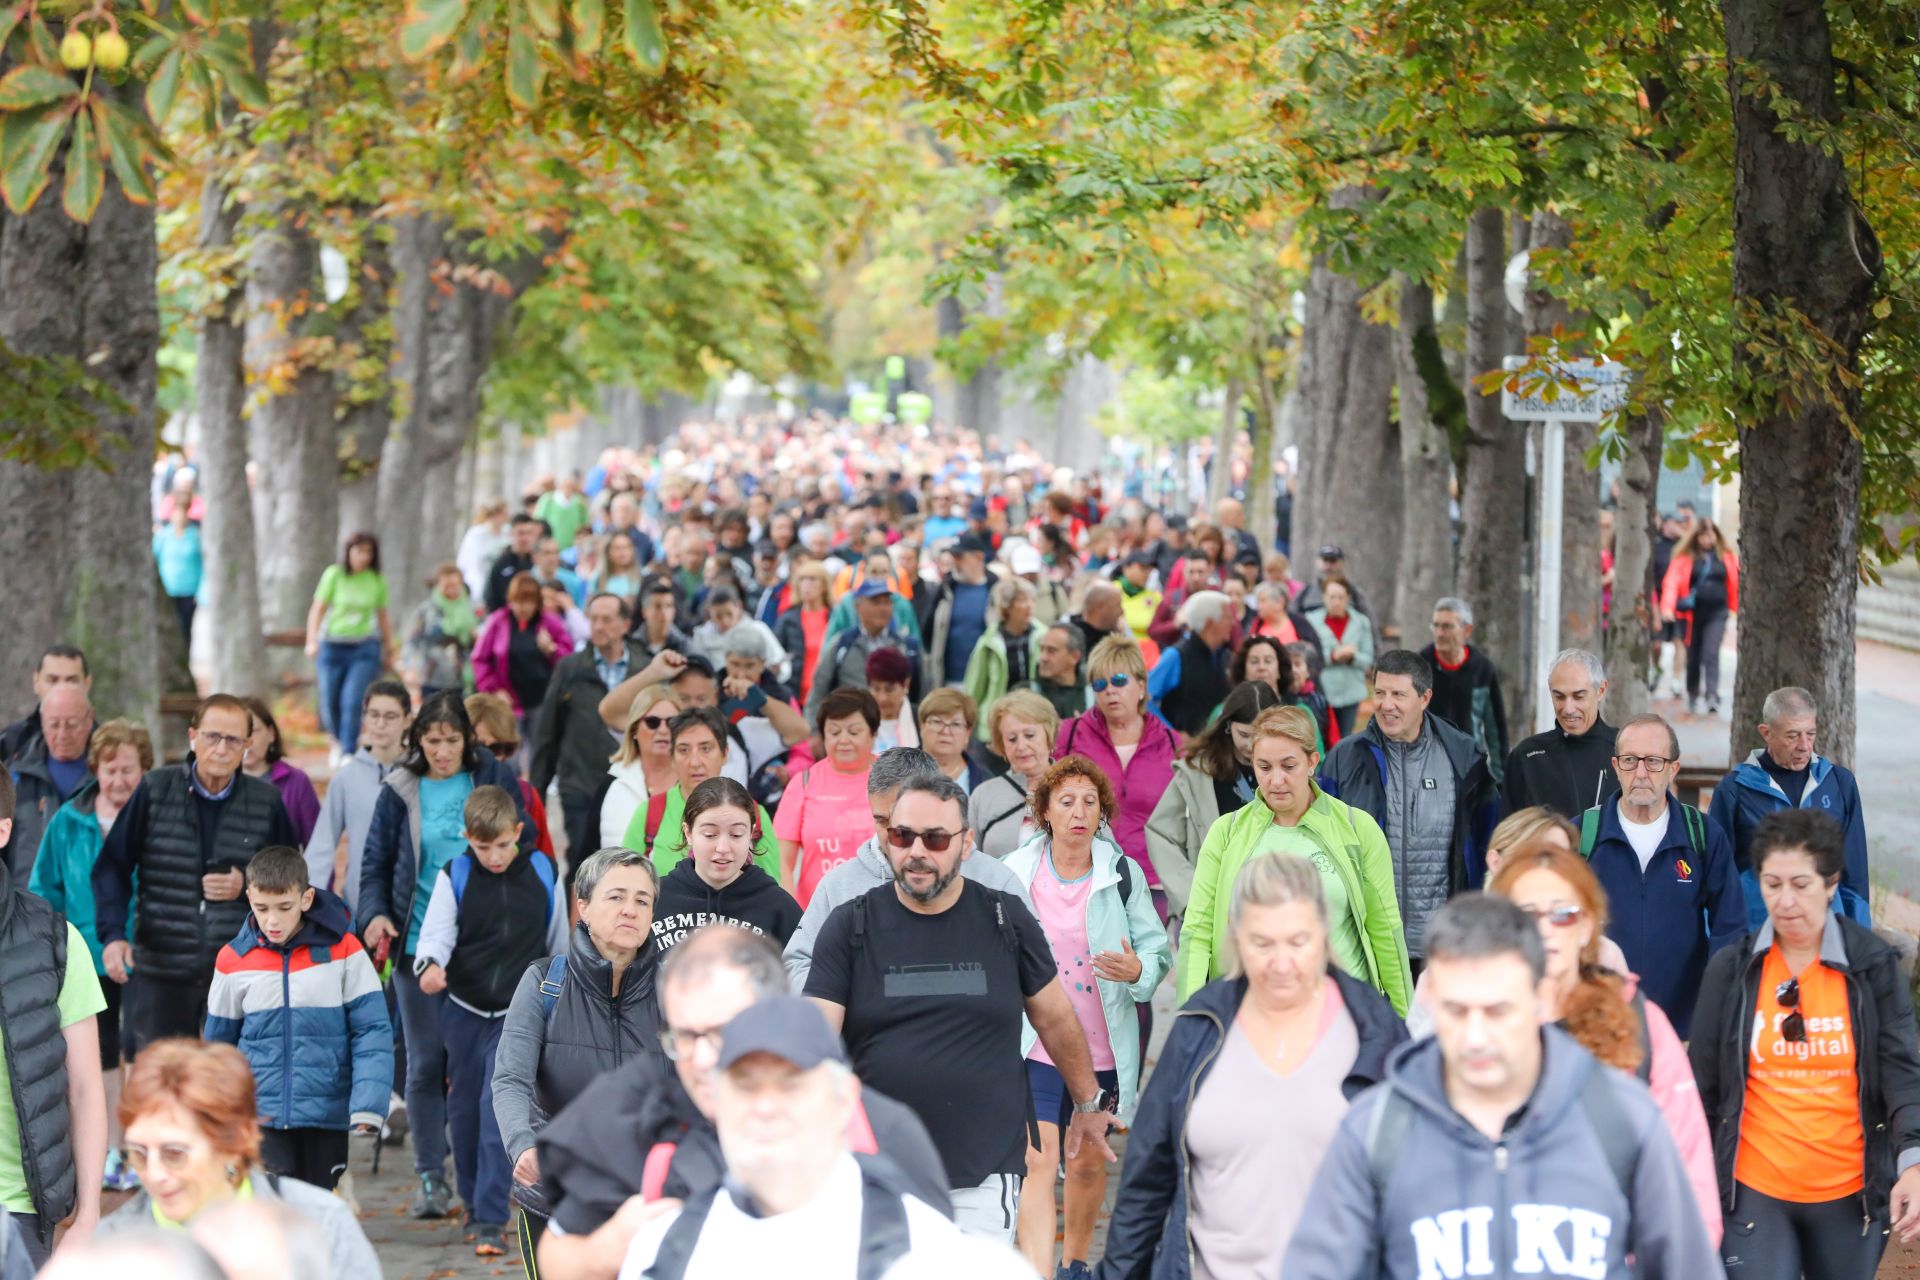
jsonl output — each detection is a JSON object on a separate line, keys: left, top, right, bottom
{"left": 1580, "top": 716, "right": 1747, "bottom": 1040}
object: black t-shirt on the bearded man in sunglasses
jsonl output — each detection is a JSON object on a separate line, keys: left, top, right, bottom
{"left": 806, "top": 881, "right": 1058, "bottom": 1186}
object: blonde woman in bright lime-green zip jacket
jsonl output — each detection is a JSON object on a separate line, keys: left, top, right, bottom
{"left": 1177, "top": 706, "right": 1413, "bottom": 1017}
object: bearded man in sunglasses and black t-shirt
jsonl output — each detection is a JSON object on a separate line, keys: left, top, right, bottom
{"left": 804, "top": 777, "right": 1117, "bottom": 1244}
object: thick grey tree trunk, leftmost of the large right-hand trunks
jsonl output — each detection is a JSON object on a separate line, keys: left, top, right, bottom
{"left": 1297, "top": 190, "right": 1400, "bottom": 633}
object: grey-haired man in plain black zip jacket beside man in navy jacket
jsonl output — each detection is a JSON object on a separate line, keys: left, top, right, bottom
{"left": 1500, "top": 649, "right": 1620, "bottom": 819}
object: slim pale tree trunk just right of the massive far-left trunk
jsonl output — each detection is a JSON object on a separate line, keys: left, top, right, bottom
{"left": 194, "top": 180, "right": 267, "bottom": 697}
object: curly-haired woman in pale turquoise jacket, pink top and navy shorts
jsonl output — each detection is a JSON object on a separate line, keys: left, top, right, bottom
{"left": 1006, "top": 756, "right": 1173, "bottom": 1276}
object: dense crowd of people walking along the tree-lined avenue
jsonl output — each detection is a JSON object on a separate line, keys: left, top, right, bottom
{"left": 0, "top": 418, "right": 1889, "bottom": 1280}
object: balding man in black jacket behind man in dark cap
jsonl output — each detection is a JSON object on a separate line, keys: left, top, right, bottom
{"left": 538, "top": 925, "right": 950, "bottom": 1280}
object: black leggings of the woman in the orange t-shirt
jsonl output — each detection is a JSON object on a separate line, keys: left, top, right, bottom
{"left": 1720, "top": 1182, "right": 1887, "bottom": 1280}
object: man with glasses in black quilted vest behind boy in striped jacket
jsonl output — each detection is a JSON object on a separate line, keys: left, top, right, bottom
{"left": 94, "top": 693, "right": 303, "bottom": 1057}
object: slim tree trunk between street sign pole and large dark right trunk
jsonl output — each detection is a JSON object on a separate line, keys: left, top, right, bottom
{"left": 1603, "top": 405, "right": 1665, "bottom": 723}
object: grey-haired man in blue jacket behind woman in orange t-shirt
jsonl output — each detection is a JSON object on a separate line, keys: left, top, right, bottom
{"left": 1707, "top": 685, "right": 1872, "bottom": 929}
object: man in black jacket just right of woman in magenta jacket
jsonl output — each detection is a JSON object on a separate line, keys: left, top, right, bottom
{"left": 528, "top": 591, "right": 639, "bottom": 864}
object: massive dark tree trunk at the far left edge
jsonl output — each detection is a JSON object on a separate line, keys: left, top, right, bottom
{"left": 0, "top": 116, "right": 159, "bottom": 723}
